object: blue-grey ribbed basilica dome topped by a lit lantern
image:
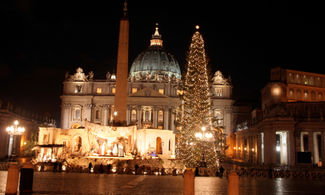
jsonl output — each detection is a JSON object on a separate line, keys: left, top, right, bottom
{"left": 130, "top": 26, "right": 181, "bottom": 80}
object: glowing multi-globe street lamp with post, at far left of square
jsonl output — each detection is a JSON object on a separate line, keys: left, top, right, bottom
{"left": 6, "top": 120, "right": 25, "bottom": 160}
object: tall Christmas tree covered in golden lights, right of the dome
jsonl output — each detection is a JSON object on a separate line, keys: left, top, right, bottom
{"left": 176, "top": 26, "right": 223, "bottom": 167}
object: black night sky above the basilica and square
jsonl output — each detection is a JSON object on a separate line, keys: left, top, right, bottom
{"left": 0, "top": 0, "right": 325, "bottom": 123}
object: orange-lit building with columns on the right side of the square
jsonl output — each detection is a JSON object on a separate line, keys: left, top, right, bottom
{"left": 233, "top": 67, "right": 325, "bottom": 166}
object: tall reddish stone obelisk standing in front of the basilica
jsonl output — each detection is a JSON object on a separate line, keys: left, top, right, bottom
{"left": 114, "top": 1, "right": 129, "bottom": 125}
